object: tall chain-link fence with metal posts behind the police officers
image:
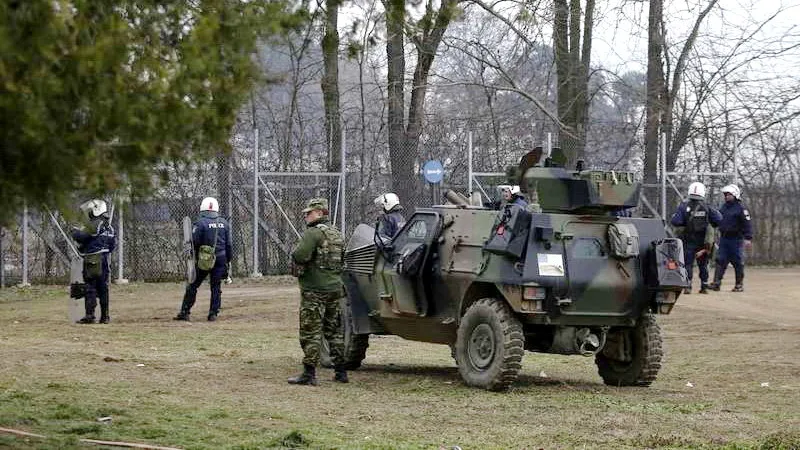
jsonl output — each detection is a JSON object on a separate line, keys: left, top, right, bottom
{"left": 0, "top": 126, "right": 800, "bottom": 286}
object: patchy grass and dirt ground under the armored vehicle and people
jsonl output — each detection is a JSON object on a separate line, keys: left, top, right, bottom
{"left": 0, "top": 268, "right": 800, "bottom": 449}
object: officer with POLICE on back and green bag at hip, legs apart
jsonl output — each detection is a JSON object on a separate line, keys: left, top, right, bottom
{"left": 175, "top": 197, "right": 233, "bottom": 322}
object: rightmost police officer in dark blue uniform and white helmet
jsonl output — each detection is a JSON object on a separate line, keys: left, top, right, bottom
{"left": 711, "top": 184, "right": 753, "bottom": 292}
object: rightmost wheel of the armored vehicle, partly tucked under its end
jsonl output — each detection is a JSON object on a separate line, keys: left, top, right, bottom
{"left": 595, "top": 314, "right": 664, "bottom": 386}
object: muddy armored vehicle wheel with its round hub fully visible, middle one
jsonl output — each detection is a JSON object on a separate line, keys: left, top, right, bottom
{"left": 455, "top": 298, "right": 525, "bottom": 391}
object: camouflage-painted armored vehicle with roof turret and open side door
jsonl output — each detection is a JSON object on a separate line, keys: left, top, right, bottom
{"left": 343, "top": 152, "right": 686, "bottom": 390}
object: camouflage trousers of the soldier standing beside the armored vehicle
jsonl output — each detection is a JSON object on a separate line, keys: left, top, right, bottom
{"left": 300, "top": 291, "right": 344, "bottom": 366}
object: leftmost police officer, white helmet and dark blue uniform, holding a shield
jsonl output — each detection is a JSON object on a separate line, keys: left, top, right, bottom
{"left": 72, "top": 199, "right": 117, "bottom": 323}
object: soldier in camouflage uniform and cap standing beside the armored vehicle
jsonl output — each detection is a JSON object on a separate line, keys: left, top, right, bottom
{"left": 288, "top": 198, "right": 348, "bottom": 386}
